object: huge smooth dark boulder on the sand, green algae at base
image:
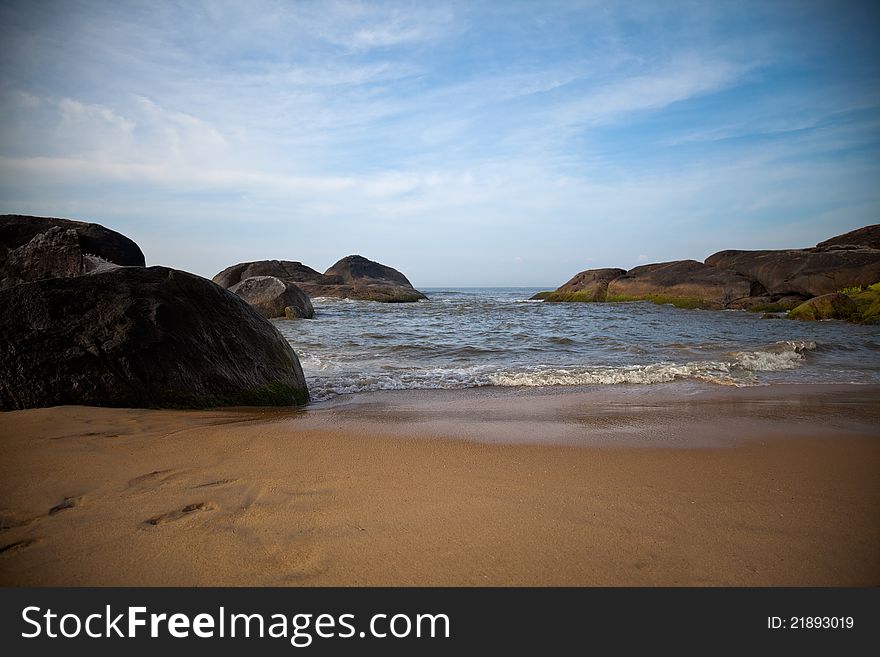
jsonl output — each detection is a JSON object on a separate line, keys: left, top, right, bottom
{"left": 0, "top": 267, "right": 308, "bottom": 410}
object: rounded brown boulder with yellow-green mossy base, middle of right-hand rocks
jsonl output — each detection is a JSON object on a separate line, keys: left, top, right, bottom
{"left": 606, "top": 260, "right": 752, "bottom": 309}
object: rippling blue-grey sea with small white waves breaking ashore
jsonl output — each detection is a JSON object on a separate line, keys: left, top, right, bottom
{"left": 274, "top": 288, "right": 880, "bottom": 401}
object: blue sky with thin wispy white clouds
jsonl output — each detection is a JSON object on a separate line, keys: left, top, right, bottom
{"left": 0, "top": 0, "right": 880, "bottom": 288}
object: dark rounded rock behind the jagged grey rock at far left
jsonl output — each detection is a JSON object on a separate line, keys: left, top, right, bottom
{"left": 0, "top": 214, "right": 145, "bottom": 270}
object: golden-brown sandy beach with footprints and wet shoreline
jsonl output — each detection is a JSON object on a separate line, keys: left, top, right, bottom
{"left": 0, "top": 385, "right": 880, "bottom": 586}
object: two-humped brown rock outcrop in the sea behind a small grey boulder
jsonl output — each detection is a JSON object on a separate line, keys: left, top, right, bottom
{"left": 213, "top": 255, "right": 425, "bottom": 303}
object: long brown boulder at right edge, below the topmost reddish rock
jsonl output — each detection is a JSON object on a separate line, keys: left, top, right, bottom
{"left": 706, "top": 247, "right": 880, "bottom": 299}
